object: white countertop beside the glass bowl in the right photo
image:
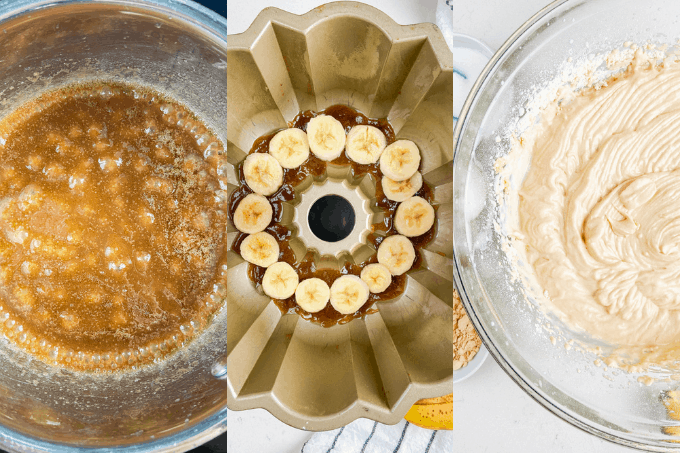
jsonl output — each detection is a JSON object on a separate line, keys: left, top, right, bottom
{"left": 453, "top": 0, "right": 633, "bottom": 453}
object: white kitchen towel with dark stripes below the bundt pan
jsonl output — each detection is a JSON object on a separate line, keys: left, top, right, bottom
{"left": 300, "top": 418, "right": 453, "bottom": 453}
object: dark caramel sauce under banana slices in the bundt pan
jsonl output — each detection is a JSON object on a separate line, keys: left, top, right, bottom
{"left": 229, "top": 105, "right": 436, "bottom": 327}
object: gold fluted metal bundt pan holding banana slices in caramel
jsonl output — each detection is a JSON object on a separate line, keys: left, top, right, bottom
{"left": 227, "top": 2, "right": 453, "bottom": 430}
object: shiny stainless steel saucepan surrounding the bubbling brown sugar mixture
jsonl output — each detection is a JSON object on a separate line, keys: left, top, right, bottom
{"left": 0, "top": 0, "right": 227, "bottom": 453}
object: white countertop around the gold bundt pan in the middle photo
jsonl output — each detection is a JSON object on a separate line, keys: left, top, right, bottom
{"left": 227, "top": 4, "right": 440, "bottom": 453}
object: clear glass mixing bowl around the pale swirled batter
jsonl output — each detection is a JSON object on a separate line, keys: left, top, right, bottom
{"left": 453, "top": 0, "right": 680, "bottom": 451}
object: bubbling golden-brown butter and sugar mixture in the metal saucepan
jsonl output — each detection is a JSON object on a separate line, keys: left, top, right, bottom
{"left": 0, "top": 84, "right": 227, "bottom": 370}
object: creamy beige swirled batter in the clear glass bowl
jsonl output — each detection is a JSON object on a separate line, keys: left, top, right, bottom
{"left": 518, "top": 52, "right": 680, "bottom": 347}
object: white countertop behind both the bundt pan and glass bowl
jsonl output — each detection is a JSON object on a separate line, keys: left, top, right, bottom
{"left": 227, "top": 0, "right": 631, "bottom": 453}
